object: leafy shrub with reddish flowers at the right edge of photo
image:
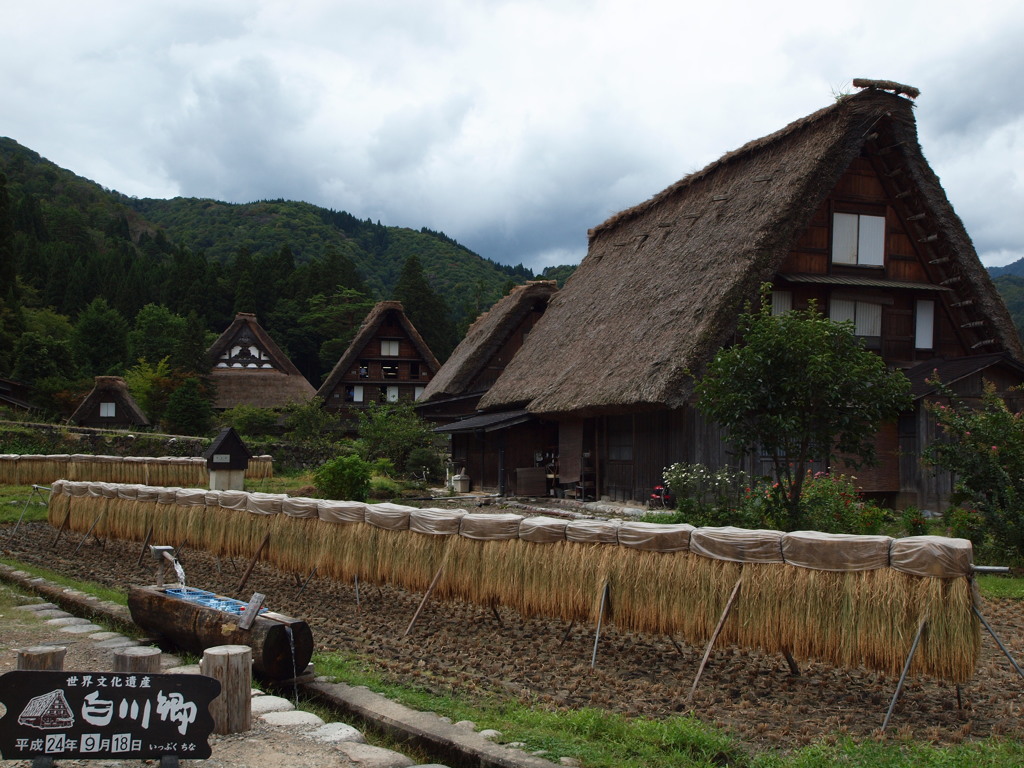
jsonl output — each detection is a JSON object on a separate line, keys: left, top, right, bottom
{"left": 923, "top": 381, "right": 1024, "bottom": 559}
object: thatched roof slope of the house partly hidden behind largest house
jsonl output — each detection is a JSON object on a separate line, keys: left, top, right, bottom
{"left": 419, "top": 280, "right": 558, "bottom": 403}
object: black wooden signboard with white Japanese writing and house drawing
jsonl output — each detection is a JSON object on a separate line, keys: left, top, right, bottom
{"left": 0, "top": 671, "right": 220, "bottom": 760}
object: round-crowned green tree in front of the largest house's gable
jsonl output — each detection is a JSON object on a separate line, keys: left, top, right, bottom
{"left": 696, "top": 287, "right": 911, "bottom": 529}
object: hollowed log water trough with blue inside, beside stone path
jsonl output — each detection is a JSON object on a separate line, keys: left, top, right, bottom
{"left": 128, "top": 587, "right": 313, "bottom": 680}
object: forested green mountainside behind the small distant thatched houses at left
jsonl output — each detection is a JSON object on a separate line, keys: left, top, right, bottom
{"left": 0, "top": 138, "right": 571, "bottom": 421}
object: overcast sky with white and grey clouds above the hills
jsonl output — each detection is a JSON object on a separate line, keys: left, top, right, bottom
{"left": 0, "top": 0, "right": 1024, "bottom": 270}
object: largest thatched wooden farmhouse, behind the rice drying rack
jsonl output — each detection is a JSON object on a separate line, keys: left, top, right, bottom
{"left": 426, "top": 81, "right": 1024, "bottom": 509}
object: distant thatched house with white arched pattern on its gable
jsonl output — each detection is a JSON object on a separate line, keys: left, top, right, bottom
{"left": 207, "top": 312, "right": 315, "bottom": 410}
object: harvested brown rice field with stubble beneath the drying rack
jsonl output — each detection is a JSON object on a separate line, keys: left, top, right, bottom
{"left": 0, "top": 521, "right": 1024, "bottom": 751}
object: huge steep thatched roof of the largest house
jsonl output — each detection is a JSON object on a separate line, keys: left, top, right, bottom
{"left": 480, "top": 88, "right": 1022, "bottom": 415}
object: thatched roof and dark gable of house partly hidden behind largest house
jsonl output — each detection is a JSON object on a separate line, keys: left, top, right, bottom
{"left": 419, "top": 281, "right": 558, "bottom": 403}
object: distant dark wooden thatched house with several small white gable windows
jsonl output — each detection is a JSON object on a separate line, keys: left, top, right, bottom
{"left": 316, "top": 301, "right": 440, "bottom": 427}
